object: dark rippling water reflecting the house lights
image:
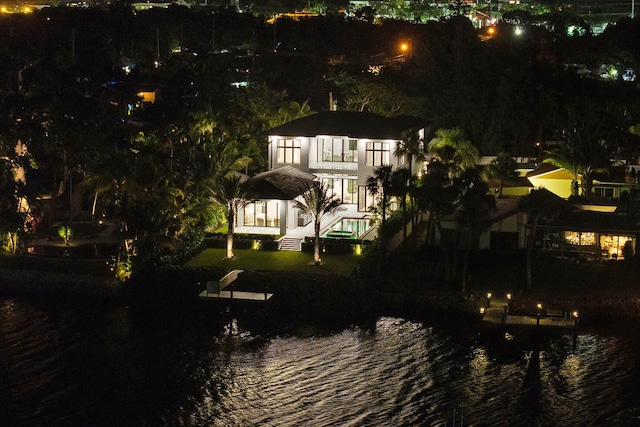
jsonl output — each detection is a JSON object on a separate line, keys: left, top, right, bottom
{"left": 0, "top": 299, "right": 640, "bottom": 426}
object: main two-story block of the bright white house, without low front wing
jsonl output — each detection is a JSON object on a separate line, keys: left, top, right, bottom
{"left": 268, "top": 111, "right": 429, "bottom": 212}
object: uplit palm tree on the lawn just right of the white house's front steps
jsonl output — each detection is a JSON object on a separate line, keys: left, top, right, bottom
{"left": 293, "top": 182, "right": 343, "bottom": 265}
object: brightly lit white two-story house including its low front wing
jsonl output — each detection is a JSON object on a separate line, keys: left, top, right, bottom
{"left": 238, "top": 111, "right": 429, "bottom": 234}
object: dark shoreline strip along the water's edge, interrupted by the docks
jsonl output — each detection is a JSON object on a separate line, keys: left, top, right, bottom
{"left": 0, "top": 269, "right": 640, "bottom": 325}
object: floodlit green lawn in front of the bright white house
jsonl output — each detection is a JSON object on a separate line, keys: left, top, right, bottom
{"left": 186, "top": 249, "right": 360, "bottom": 276}
